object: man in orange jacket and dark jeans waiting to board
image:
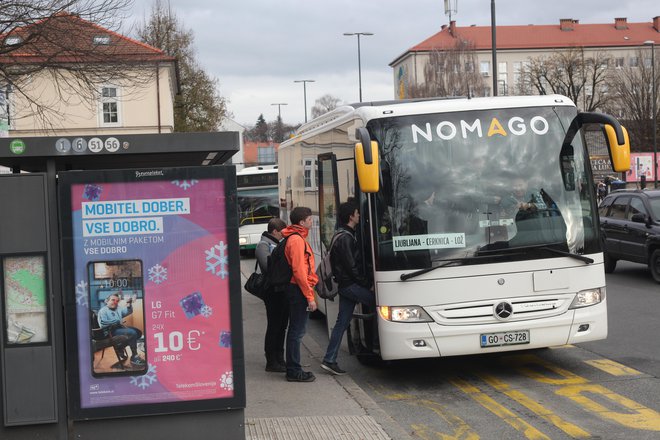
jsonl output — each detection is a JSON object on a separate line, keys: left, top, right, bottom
{"left": 282, "top": 206, "right": 318, "bottom": 382}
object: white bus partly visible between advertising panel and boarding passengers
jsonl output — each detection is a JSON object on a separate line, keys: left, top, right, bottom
{"left": 236, "top": 165, "right": 280, "bottom": 252}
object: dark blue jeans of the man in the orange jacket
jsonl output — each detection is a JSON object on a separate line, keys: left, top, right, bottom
{"left": 284, "top": 284, "right": 309, "bottom": 377}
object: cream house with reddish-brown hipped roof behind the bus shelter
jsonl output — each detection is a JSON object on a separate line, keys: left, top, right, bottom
{"left": 0, "top": 14, "right": 179, "bottom": 137}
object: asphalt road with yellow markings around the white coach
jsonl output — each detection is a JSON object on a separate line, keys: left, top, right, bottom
{"left": 310, "top": 263, "right": 660, "bottom": 439}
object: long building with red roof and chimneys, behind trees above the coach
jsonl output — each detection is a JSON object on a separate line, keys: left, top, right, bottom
{"left": 390, "top": 16, "right": 660, "bottom": 99}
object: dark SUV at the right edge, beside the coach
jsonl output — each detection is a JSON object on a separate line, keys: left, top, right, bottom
{"left": 598, "top": 190, "right": 660, "bottom": 283}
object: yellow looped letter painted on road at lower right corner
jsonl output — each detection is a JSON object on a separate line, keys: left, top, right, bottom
{"left": 555, "top": 384, "right": 660, "bottom": 431}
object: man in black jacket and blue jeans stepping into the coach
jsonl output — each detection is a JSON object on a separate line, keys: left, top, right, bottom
{"left": 321, "top": 202, "right": 376, "bottom": 375}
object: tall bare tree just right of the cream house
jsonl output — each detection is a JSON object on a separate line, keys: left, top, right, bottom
{"left": 137, "top": 0, "right": 227, "bottom": 132}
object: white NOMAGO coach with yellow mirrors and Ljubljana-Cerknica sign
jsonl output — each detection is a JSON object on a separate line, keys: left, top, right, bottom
{"left": 278, "top": 95, "right": 630, "bottom": 360}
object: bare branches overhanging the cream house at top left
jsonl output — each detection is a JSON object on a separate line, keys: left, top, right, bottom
{"left": 0, "top": 0, "right": 163, "bottom": 129}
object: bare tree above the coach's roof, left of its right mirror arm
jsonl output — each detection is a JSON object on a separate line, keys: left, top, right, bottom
{"left": 517, "top": 47, "right": 610, "bottom": 112}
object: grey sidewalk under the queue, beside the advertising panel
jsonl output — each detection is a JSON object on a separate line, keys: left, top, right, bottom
{"left": 241, "top": 260, "right": 411, "bottom": 440}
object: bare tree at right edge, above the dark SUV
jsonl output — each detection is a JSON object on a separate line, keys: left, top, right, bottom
{"left": 606, "top": 50, "right": 660, "bottom": 151}
